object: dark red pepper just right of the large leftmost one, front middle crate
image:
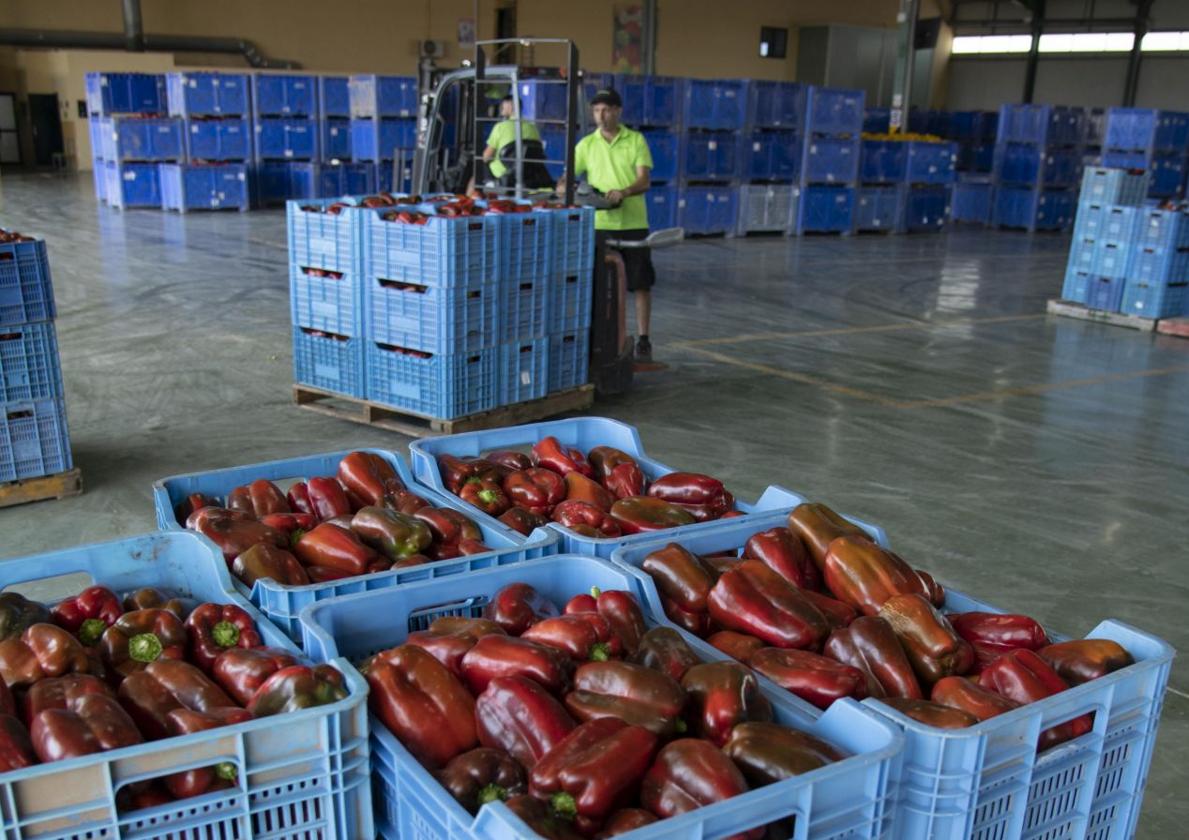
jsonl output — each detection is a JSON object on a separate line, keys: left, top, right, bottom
{"left": 474, "top": 677, "right": 575, "bottom": 769}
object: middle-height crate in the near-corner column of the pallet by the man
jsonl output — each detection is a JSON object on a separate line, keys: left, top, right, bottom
{"left": 363, "top": 277, "right": 504, "bottom": 355}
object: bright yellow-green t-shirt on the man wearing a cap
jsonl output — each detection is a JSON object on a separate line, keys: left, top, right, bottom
{"left": 574, "top": 125, "right": 653, "bottom": 231}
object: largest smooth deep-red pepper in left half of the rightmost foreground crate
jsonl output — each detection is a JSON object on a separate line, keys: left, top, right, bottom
{"left": 707, "top": 560, "right": 830, "bottom": 648}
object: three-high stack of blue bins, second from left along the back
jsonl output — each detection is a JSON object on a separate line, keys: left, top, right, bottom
{"left": 158, "top": 71, "right": 252, "bottom": 213}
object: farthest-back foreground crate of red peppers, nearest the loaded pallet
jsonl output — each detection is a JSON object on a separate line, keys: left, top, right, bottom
{"left": 409, "top": 418, "right": 865, "bottom": 557}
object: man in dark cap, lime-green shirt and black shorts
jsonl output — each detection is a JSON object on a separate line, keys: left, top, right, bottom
{"left": 574, "top": 89, "right": 656, "bottom": 362}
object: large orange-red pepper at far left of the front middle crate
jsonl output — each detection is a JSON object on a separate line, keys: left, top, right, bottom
{"left": 359, "top": 645, "right": 478, "bottom": 767}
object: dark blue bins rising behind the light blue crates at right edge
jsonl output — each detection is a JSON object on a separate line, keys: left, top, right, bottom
{"left": 1102, "top": 108, "right": 1189, "bottom": 199}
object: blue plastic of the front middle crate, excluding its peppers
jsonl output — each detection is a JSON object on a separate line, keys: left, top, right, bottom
{"left": 302, "top": 556, "right": 902, "bottom": 840}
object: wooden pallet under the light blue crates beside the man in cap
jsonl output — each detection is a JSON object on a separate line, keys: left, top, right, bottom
{"left": 294, "top": 385, "right": 595, "bottom": 438}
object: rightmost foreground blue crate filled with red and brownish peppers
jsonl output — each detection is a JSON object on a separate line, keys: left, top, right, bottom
{"left": 612, "top": 503, "right": 1172, "bottom": 840}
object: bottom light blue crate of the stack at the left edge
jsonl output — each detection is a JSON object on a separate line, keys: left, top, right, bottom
{"left": 0, "top": 397, "right": 74, "bottom": 482}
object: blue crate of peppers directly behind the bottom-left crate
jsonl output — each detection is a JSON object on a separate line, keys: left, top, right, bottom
{"left": 153, "top": 450, "right": 558, "bottom": 641}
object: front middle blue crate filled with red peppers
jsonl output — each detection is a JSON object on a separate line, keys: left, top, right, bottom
{"left": 302, "top": 556, "right": 901, "bottom": 840}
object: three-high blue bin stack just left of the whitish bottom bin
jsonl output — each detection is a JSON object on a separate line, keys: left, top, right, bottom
{"left": 677, "top": 79, "right": 748, "bottom": 236}
